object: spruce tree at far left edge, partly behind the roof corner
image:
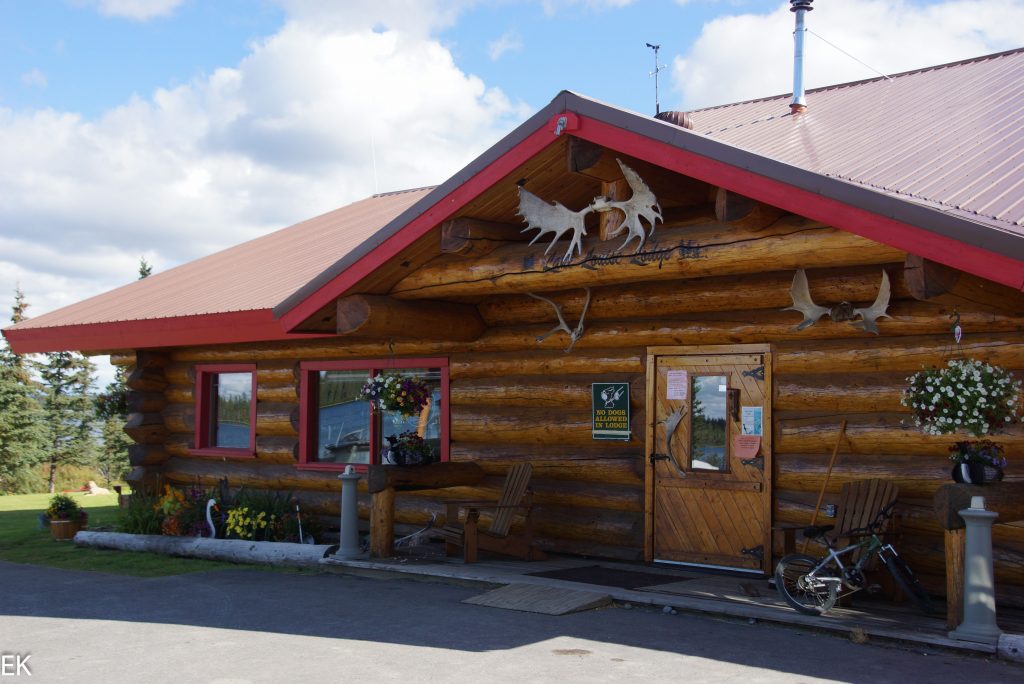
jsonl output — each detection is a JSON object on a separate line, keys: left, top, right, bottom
{"left": 0, "top": 288, "right": 46, "bottom": 494}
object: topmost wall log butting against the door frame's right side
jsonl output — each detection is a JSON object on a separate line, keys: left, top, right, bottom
{"left": 773, "top": 326, "right": 1024, "bottom": 376}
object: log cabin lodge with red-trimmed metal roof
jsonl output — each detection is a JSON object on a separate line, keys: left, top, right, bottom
{"left": 3, "top": 49, "right": 1024, "bottom": 601}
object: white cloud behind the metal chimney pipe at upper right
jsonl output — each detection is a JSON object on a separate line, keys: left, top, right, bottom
{"left": 672, "top": 0, "right": 1024, "bottom": 110}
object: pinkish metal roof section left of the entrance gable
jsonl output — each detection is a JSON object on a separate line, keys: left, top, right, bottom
{"left": 4, "top": 188, "right": 430, "bottom": 331}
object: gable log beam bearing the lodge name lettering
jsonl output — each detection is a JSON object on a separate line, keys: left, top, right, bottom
{"left": 391, "top": 215, "right": 904, "bottom": 299}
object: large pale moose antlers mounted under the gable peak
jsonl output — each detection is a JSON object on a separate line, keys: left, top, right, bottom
{"left": 518, "top": 159, "right": 665, "bottom": 261}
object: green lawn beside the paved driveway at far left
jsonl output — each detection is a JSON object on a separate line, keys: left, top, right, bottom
{"left": 0, "top": 494, "right": 247, "bottom": 578}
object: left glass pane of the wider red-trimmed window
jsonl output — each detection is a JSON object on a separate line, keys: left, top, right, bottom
{"left": 316, "top": 371, "right": 370, "bottom": 463}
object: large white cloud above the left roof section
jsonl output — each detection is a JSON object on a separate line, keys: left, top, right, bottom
{"left": 0, "top": 12, "right": 531, "bottom": 315}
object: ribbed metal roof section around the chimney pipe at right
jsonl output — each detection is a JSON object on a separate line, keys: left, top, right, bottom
{"left": 690, "top": 49, "right": 1024, "bottom": 232}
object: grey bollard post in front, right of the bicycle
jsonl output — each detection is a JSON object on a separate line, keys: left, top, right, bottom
{"left": 949, "top": 497, "right": 1002, "bottom": 646}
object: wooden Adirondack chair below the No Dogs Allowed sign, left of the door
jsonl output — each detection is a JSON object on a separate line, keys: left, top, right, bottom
{"left": 438, "top": 463, "right": 547, "bottom": 563}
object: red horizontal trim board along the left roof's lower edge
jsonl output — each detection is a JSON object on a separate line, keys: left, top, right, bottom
{"left": 4, "top": 309, "right": 331, "bottom": 353}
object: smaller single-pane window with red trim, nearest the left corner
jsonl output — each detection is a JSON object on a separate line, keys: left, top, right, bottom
{"left": 193, "top": 364, "right": 256, "bottom": 457}
